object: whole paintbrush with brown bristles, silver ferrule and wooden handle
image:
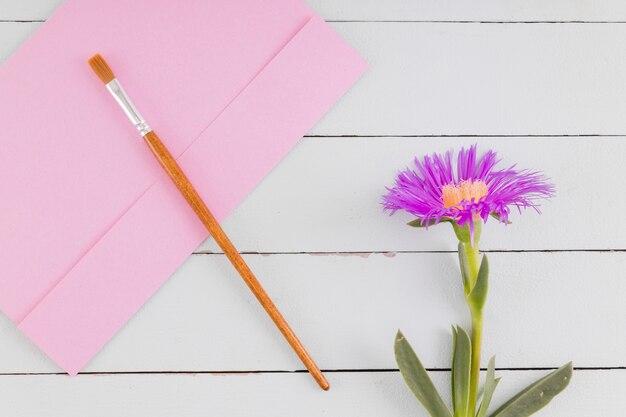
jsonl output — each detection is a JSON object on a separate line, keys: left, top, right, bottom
{"left": 89, "top": 54, "right": 330, "bottom": 390}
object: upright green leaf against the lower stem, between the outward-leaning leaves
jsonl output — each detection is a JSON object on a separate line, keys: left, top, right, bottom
{"left": 452, "top": 326, "right": 472, "bottom": 417}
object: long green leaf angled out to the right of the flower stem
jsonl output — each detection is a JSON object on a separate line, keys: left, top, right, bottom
{"left": 491, "top": 362, "right": 573, "bottom": 417}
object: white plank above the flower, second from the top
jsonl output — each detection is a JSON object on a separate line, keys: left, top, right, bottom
{"left": 0, "top": 23, "right": 626, "bottom": 135}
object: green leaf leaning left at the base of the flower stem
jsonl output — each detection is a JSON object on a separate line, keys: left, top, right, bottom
{"left": 394, "top": 330, "right": 452, "bottom": 417}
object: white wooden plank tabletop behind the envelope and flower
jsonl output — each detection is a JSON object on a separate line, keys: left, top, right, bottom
{"left": 0, "top": 0, "right": 626, "bottom": 417}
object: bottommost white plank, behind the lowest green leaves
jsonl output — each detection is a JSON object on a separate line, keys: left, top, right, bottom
{"left": 0, "top": 370, "right": 626, "bottom": 417}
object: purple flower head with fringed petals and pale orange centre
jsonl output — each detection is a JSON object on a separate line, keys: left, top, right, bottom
{"left": 383, "top": 145, "right": 554, "bottom": 234}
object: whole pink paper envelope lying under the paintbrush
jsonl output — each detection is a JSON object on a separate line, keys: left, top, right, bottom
{"left": 0, "top": 0, "right": 366, "bottom": 374}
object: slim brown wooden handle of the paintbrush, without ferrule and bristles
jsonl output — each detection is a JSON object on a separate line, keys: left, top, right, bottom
{"left": 144, "top": 132, "right": 330, "bottom": 390}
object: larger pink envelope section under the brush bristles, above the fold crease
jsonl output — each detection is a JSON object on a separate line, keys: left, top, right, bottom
{"left": 0, "top": 0, "right": 312, "bottom": 322}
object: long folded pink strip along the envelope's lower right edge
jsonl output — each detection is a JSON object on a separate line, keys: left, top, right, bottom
{"left": 19, "top": 16, "right": 367, "bottom": 375}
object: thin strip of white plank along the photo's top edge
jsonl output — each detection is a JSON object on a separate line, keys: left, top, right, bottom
{"left": 0, "top": 0, "right": 626, "bottom": 22}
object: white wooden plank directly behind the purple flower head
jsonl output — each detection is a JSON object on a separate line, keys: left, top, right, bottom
{"left": 200, "top": 138, "right": 626, "bottom": 252}
